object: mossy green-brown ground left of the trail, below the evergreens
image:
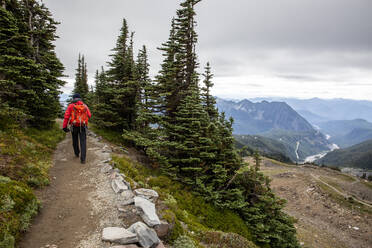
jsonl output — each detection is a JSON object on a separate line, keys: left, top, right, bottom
{"left": 0, "top": 125, "right": 65, "bottom": 248}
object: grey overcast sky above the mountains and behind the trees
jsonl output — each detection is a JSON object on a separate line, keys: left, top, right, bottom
{"left": 43, "top": 0, "right": 372, "bottom": 100}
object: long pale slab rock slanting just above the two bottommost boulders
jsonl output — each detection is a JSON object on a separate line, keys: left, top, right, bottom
{"left": 134, "top": 196, "right": 161, "bottom": 227}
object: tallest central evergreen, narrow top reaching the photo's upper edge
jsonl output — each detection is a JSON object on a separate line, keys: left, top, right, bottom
{"left": 157, "top": 0, "right": 200, "bottom": 122}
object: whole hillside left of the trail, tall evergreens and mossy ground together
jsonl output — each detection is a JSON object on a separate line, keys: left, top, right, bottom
{"left": 0, "top": 0, "right": 64, "bottom": 247}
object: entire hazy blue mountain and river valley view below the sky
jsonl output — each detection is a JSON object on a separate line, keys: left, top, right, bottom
{"left": 216, "top": 98, "right": 372, "bottom": 169}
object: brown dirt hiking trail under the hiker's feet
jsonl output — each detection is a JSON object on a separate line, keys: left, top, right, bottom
{"left": 18, "top": 131, "right": 123, "bottom": 248}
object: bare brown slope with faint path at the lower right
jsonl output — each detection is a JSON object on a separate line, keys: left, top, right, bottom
{"left": 248, "top": 159, "right": 372, "bottom": 248}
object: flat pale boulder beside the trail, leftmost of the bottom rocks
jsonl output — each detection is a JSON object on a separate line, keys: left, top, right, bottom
{"left": 102, "top": 227, "right": 138, "bottom": 245}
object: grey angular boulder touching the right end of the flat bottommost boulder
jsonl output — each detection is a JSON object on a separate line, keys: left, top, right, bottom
{"left": 128, "top": 221, "right": 160, "bottom": 248}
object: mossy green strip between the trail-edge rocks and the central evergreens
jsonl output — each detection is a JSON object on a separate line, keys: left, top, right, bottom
{"left": 92, "top": 127, "right": 257, "bottom": 248}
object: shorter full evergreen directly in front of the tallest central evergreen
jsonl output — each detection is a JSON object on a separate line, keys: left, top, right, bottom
{"left": 165, "top": 87, "right": 214, "bottom": 180}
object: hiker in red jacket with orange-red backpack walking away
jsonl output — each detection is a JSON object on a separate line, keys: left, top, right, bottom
{"left": 63, "top": 93, "right": 92, "bottom": 164}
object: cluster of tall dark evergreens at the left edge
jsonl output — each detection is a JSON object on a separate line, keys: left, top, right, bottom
{"left": 0, "top": 0, "right": 64, "bottom": 126}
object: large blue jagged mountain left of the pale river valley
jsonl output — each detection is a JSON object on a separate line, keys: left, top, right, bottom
{"left": 217, "top": 98, "right": 330, "bottom": 162}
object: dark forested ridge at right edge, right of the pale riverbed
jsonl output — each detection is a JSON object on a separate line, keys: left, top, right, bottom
{"left": 316, "top": 139, "right": 372, "bottom": 170}
